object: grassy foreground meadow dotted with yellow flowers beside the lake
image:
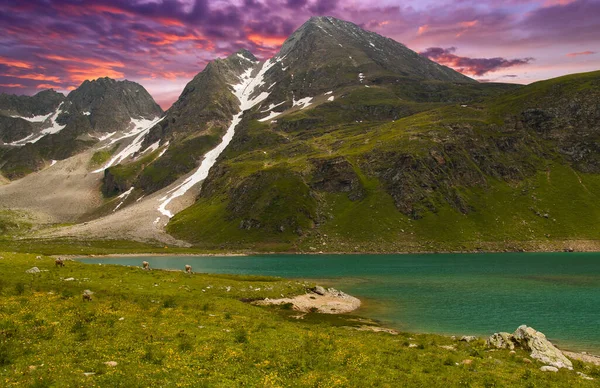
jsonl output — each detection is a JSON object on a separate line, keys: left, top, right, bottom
{"left": 0, "top": 253, "right": 600, "bottom": 387}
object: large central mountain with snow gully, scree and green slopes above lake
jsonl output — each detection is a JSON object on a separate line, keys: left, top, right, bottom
{"left": 0, "top": 17, "right": 600, "bottom": 252}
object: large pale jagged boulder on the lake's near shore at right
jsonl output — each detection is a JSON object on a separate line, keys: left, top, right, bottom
{"left": 486, "top": 325, "right": 573, "bottom": 369}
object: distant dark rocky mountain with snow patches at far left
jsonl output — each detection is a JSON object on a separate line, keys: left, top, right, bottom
{"left": 0, "top": 78, "right": 162, "bottom": 179}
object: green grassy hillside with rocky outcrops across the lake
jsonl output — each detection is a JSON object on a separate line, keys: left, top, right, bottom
{"left": 168, "top": 72, "right": 600, "bottom": 252}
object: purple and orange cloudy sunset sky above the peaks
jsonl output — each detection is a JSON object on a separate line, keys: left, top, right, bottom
{"left": 0, "top": 0, "right": 600, "bottom": 109}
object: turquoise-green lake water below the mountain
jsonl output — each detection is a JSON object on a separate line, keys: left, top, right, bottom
{"left": 81, "top": 253, "right": 600, "bottom": 353}
